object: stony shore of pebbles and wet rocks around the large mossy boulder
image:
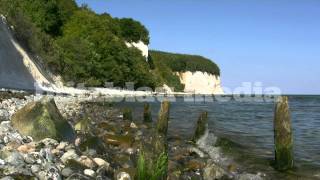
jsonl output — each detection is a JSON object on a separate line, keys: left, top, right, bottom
{"left": 0, "top": 94, "right": 263, "bottom": 180}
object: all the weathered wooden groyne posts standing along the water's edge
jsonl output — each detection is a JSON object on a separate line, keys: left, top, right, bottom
{"left": 123, "top": 96, "right": 294, "bottom": 180}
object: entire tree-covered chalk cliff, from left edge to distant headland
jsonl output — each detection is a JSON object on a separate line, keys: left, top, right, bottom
{"left": 0, "top": 0, "right": 221, "bottom": 94}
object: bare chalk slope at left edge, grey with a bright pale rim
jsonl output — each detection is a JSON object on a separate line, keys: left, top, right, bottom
{"left": 0, "top": 15, "right": 50, "bottom": 90}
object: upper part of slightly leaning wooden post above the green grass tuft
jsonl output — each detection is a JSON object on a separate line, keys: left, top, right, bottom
{"left": 157, "top": 101, "right": 170, "bottom": 136}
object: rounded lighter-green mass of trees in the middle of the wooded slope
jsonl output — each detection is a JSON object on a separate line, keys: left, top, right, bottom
{"left": 57, "top": 9, "right": 155, "bottom": 87}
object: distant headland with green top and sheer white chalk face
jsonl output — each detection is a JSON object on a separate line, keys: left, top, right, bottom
{"left": 148, "top": 51, "right": 223, "bottom": 94}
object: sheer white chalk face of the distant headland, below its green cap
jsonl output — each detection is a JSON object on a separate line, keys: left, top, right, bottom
{"left": 178, "top": 71, "right": 224, "bottom": 94}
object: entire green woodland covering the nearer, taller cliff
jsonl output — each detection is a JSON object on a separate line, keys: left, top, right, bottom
{"left": 0, "top": 0, "right": 156, "bottom": 87}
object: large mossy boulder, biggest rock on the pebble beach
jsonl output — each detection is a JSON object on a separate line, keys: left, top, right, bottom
{"left": 12, "top": 97, "right": 75, "bottom": 141}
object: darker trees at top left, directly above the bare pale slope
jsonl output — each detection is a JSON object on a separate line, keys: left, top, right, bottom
{"left": 0, "top": 0, "right": 73, "bottom": 78}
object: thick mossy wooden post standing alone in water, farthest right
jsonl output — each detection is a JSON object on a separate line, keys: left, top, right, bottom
{"left": 274, "top": 96, "right": 293, "bottom": 171}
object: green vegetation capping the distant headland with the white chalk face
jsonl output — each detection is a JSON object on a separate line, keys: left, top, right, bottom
{"left": 149, "top": 51, "right": 220, "bottom": 92}
